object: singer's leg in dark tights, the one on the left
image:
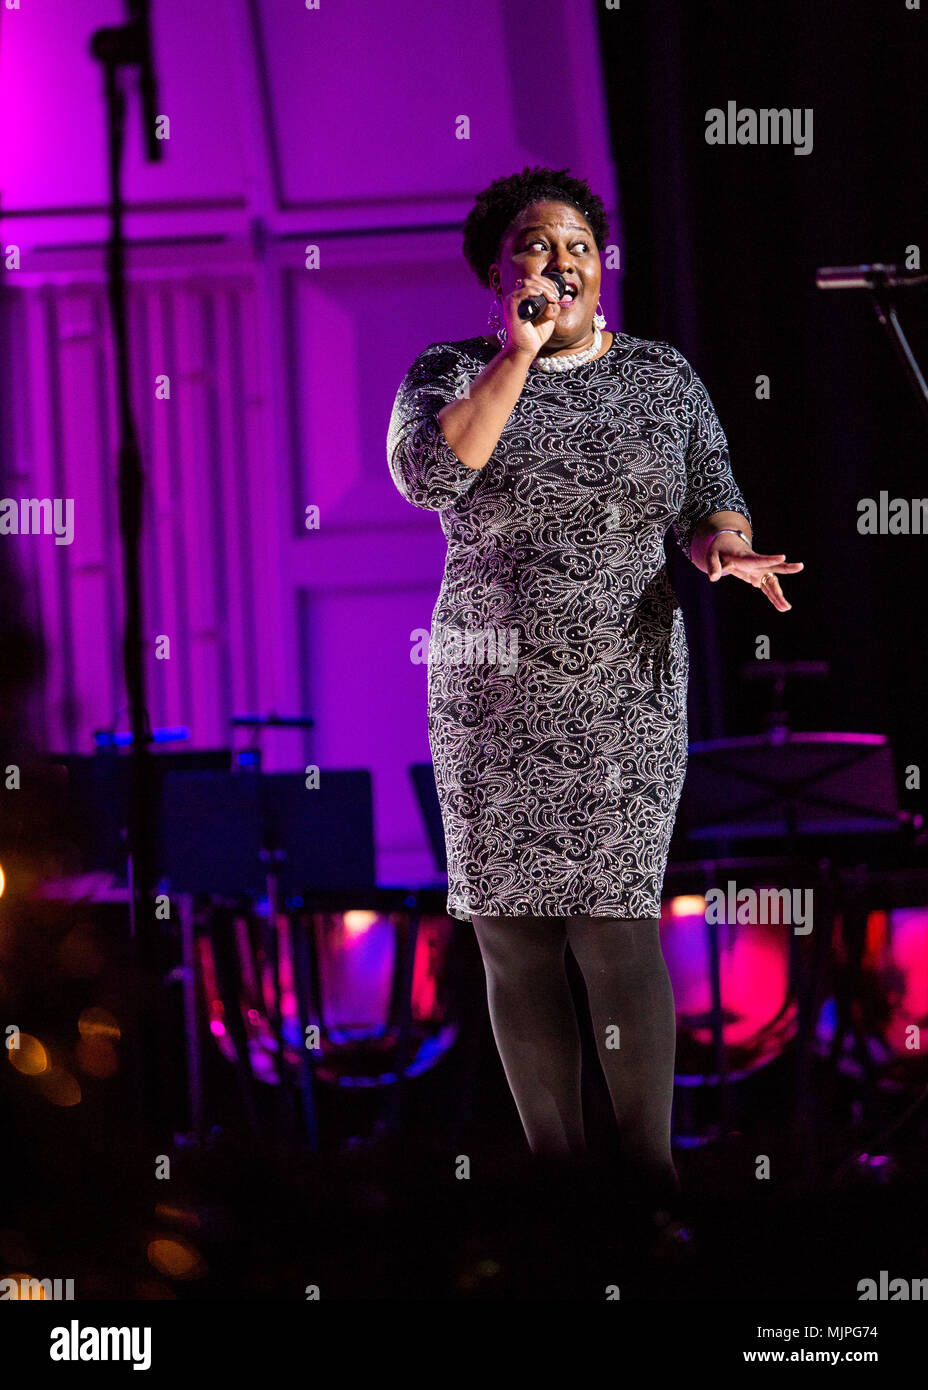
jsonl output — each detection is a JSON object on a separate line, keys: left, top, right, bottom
{"left": 474, "top": 917, "right": 583, "bottom": 1156}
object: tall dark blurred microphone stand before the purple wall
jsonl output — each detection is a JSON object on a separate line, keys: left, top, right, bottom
{"left": 90, "top": 0, "right": 161, "bottom": 1143}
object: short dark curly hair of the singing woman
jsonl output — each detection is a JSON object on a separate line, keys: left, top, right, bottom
{"left": 463, "top": 164, "right": 608, "bottom": 289}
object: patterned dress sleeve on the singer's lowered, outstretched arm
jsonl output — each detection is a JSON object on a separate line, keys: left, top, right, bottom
{"left": 672, "top": 353, "right": 753, "bottom": 559}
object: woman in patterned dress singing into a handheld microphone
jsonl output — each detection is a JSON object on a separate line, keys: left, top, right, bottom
{"left": 388, "top": 168, "right": 802, "bottom": 1245}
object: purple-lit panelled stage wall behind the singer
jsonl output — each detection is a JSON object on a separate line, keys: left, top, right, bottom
{"left": 0, "top": 0, "right": 621, "bottom": 883}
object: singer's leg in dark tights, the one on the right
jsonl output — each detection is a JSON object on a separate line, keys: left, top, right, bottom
{"left": 567, "top": 917, "right": 679, "bottom": 1205}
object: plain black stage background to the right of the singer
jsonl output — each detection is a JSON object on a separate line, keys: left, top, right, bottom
{"left": 599, "top": 0, "right": 928, "bottom": 772}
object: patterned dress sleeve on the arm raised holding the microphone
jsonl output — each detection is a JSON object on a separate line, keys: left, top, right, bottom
{"left": 386, "top": 343, "right": 482, "bottom": 512}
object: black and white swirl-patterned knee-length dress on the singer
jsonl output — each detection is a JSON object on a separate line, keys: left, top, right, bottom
{"left": 386, "top": 334, "right": 750, "bottom": 922}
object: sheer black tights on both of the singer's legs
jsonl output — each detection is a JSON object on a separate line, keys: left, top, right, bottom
{"left": 474, "top": 917, "right": 679, "bottom": 1204}
